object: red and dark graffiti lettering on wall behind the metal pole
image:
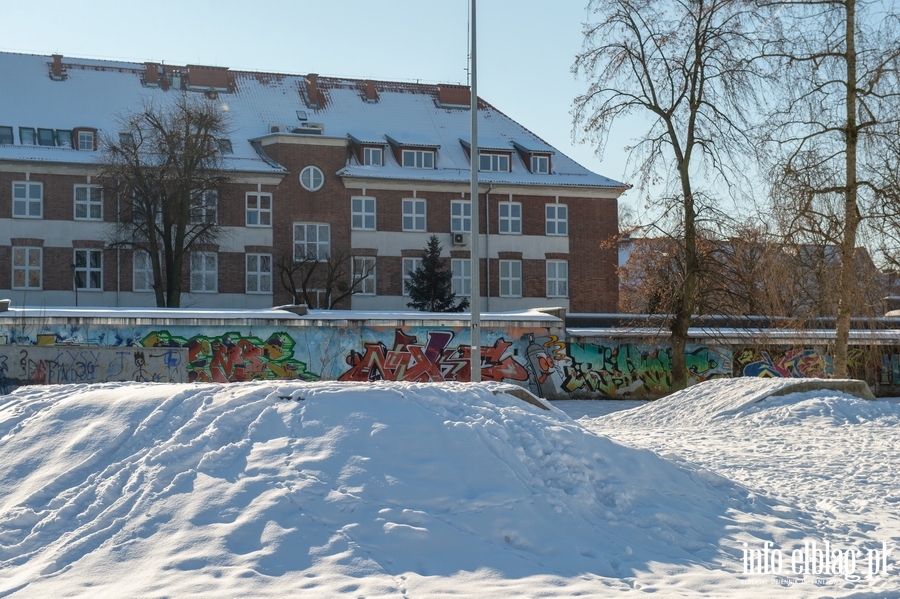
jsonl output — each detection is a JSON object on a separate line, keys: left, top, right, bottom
{"left": 338, "top": 329, "right": 528, "bottom": 382}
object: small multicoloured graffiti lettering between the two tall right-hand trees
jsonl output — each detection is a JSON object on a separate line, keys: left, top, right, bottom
{"left": 734, "top": 347, "right": 834, "bottom": 378}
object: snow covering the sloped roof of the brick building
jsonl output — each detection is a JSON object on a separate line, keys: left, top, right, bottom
{"left": 0, "top": 53, "right": 624, "bottom": 188}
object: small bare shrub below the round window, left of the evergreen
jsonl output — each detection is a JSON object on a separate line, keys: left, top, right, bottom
{"left": 275, "top": 252, "right": 375, "bottom": 310}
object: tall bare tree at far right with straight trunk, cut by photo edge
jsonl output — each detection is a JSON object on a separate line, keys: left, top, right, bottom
{"left": 761, "top": 0, "right": 900, "bottom": 378}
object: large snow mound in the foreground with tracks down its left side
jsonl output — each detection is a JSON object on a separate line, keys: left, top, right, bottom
{"left": 0, "top": 382, "right": 800, "bottom": 597}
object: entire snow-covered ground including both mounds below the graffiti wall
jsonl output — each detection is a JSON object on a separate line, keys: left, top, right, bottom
{"left": 0, "top": 379, "right": 900, "bottom": 597}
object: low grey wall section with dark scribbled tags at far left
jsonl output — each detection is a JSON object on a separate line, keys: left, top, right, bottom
{"left": 0, "top": 345, "right": 188, "bottom": 394}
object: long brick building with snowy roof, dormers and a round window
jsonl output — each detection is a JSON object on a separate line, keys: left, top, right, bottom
{"left": 0, "top": 53, "right": 625, "bottom": 312}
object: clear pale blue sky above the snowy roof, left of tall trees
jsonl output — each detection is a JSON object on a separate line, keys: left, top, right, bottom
{"left": 0, "top": 0, "right": 634, "bottom": 206}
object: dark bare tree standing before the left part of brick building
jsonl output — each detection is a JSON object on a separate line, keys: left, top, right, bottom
{"left": 99, "top": 93, "right": 231, "bottom": 308}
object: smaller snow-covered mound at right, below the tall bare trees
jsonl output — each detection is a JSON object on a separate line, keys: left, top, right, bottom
{"left": 609, "top": 377, "right": 871, "bottom": 427}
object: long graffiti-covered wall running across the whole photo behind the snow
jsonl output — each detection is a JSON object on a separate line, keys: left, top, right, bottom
{"left": 0, "top": 320, "right": 900, "bottom": 399}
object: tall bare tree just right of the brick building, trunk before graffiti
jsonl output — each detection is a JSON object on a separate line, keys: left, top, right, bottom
{"left": 573, "top": 0, "right": 759, "bottom": 389}
